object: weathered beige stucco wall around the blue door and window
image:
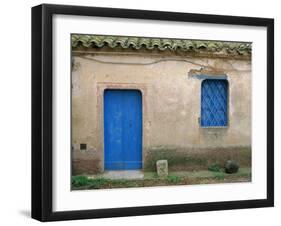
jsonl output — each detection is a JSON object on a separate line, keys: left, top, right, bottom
{"left": 72, "top": 52, "right": 251, "bottom": 174}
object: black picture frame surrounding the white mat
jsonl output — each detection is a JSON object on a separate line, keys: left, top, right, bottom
{"left": 32, "top": 4, "right": 274, "bottom": 221}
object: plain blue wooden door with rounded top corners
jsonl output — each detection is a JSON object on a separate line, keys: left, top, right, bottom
{"left": 104, "top": 90, "right": 142, "bottom": 170}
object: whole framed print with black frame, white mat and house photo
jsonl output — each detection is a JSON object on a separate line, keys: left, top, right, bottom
{"left": 32, "top": 4, "right": 274, "bottom": 221}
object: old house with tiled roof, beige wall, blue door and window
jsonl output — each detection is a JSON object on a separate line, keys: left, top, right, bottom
{"left": 71, "top": 35, "right": 251, "bottom": 174}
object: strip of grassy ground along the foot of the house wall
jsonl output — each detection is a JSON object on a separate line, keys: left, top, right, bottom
{"left": 71, "top": 168, "right": 251, "bottom": 190}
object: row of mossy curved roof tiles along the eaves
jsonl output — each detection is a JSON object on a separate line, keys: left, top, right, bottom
{"left": 71, "top": 34, "right": 252, "bottom": 56}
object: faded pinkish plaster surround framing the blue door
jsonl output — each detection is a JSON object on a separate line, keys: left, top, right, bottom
{"left": 95, "top": 82, "right": 149, "bottom": 171}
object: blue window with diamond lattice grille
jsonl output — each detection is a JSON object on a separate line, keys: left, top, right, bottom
{"left": 201, "top": 79, "right": 228, "bottom": 127}
